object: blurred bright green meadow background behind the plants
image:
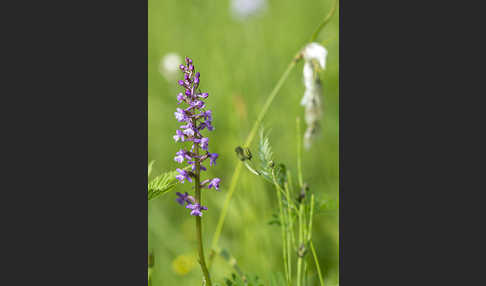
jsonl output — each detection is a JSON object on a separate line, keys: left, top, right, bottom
{"left": 148, "top": 0, "right": 339, "bottom": 286}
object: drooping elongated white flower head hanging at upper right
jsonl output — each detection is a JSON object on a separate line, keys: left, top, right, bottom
{"left": 300, "top": 43, "right": 327, "bottom": 149}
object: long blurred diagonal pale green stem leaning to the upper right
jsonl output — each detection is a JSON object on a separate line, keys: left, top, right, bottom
{"left": 209, "top": 0, "right": 337, "bottom": 266}
